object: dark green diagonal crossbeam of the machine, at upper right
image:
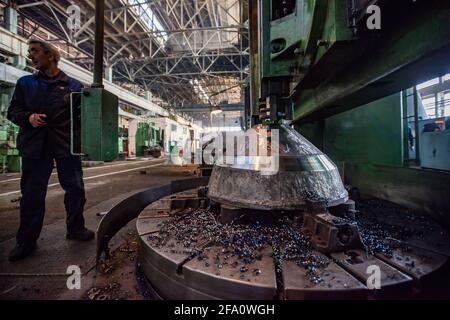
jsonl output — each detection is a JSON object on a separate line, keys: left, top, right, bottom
{"left": 291, "top": 1, "right": 450, "bottom": 122}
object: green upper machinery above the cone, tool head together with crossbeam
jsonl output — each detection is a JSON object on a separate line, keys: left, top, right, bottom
{"left": 247, "top": 0, "right": 450, "bottom": 125}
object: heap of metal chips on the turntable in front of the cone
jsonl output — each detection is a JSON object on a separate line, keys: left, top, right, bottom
{"left": 148, "top": 209, "right": 329, "bottom": 283}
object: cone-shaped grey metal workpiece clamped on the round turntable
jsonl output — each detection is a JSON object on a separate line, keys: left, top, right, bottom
{"left": 208, "top": 124, "right": 348, "bottom": 210}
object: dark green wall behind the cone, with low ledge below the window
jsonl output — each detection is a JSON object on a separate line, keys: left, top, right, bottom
{"left": 298, "top": 93, "right": 450, "bottom": 226}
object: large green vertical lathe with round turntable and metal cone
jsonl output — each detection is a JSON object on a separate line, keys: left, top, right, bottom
{"left": 98, "top": 0, "right": 450, "bottom": 299}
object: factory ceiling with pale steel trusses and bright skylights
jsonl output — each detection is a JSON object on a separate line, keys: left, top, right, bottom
{"left": 7, "top": 0, "right": 249, "bottom": 122}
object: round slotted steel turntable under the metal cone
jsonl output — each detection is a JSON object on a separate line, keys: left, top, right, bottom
{"left": 137, "top": 186, "right": 450, "bottom": 300}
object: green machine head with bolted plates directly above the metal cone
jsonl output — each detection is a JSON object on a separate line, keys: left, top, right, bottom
{"left": 261, "top": 0, "right": 353, "bottom": 78}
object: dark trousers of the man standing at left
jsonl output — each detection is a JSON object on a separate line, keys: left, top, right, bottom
{"left": 17, "top": 156, "right": 86, "bottom": 244}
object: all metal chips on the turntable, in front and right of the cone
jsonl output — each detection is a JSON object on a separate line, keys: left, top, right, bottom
{"left": 148, "top": 200, "right": 442, "bottom": 284}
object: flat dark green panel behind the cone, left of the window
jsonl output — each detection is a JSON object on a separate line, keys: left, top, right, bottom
{"left": 323, "top": 93, "right": 403, "bottom": 166}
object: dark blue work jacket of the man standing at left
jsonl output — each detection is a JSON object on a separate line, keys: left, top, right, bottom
{"left": 8, "top": 71, "right": 81, "bottom": 159}
